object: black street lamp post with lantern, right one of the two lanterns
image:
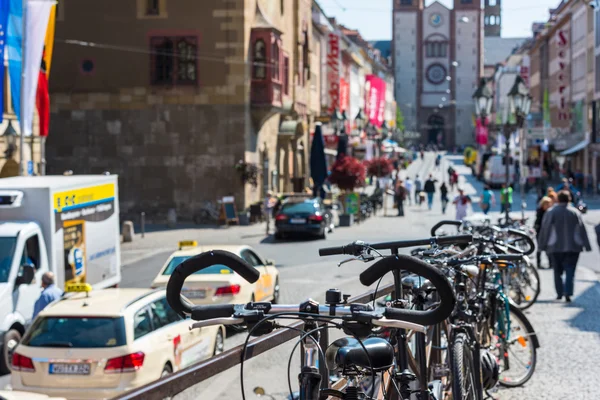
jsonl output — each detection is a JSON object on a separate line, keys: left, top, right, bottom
{"left": 502, "top": 75, "right": 531, "bottom": 221}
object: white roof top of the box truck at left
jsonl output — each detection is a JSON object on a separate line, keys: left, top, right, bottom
{"left": 0, "top": 175, "right": 117, "bottom": 189}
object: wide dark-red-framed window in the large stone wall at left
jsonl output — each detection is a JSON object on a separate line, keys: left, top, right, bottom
{"left": 150, "top": 36, "right": 198, "bottom": 85}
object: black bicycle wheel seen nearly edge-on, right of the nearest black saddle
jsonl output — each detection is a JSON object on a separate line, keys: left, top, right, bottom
{"left": 450, "top": 332, "right": 480, "bottom": 400}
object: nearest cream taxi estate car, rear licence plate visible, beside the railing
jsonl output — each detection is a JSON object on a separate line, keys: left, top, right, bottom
{"left": 11, "top": 284, "right": 225, "bottom": 399}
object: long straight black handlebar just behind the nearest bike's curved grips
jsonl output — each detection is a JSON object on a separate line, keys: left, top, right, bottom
{"left": 319, "top": 235, "right": 473, "bottom": 256}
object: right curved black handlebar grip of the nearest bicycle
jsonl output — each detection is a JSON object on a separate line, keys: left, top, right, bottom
{"left": 360, "top": 255, "right": 456, "bottom": 325}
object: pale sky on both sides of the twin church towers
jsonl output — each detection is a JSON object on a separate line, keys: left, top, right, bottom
{"left": 317, "top": 0, "right": 560, "bottom": 40}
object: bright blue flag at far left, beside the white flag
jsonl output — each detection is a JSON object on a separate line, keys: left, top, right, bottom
{"left": 2, "top": 0, "right": 23, "bottom": 121}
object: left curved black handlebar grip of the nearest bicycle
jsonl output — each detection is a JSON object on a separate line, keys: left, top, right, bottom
{"left": 167, "top": 250, "right": 260, "bottom": 317}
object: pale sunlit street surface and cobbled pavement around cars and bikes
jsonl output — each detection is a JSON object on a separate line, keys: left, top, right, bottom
{"left": 0, "top": 154, "right": 600, "bottom": 400}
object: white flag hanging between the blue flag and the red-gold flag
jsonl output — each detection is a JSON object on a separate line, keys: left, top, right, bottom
{"left": 21, "top": 0, "right": 55, "bottom": 136}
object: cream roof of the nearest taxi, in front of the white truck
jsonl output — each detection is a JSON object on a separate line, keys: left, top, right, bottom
{"left": 40, "top": 289, "right": 158, "bottom": 317}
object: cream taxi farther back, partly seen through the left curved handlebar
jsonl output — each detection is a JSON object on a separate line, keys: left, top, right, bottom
{"left": 152, "top": 241, "right": 279, "bottom": 304}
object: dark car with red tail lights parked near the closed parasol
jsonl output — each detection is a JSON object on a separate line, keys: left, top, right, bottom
{"left": 275, "top": 198, "right": 332, "bottom": 239}
